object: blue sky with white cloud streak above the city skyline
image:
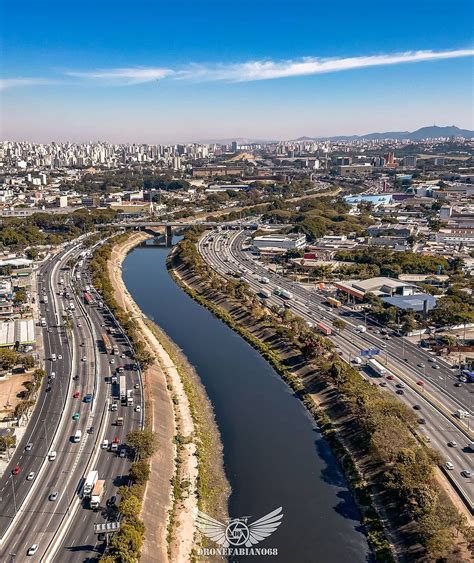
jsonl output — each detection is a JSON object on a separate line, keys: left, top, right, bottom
{"left": 0, "top": 0, "right": 474, "bottom": 143}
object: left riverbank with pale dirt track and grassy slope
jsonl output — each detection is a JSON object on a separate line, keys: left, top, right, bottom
{"left": 109, "top": 233, "right": 229, "bottom": 562}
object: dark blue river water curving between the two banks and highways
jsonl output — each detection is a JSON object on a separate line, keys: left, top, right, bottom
{"left": 123, "top": 243, "right": 371, "bottom": 563}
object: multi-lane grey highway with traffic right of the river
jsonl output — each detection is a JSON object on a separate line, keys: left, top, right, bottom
{"left": 198, "top": 231, "right": 474, "bottom": 511}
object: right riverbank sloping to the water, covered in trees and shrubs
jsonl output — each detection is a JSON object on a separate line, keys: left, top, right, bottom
{"left": 168, "top": 233, "right": 474, "bottom": 561}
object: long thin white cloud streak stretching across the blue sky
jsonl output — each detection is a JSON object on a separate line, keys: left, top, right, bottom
{"left": 0, "top": 49, "right": 474, "bottom": 89}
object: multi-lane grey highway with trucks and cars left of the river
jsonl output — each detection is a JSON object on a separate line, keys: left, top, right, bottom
{"left": 0, "top": 243, "right": 144, "bottom": 561}
